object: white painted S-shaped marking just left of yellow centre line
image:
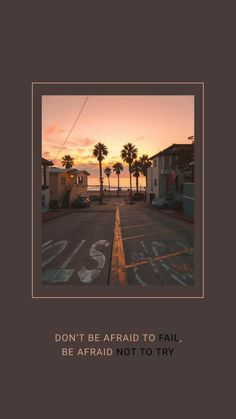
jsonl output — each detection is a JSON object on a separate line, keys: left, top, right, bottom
{"left": 78, "top": 240, "right": 109, "bottom": 284}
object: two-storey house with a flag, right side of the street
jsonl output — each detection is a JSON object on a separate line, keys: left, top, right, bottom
{"left": 147, "top": 144, "right": 194, "bottom": 216}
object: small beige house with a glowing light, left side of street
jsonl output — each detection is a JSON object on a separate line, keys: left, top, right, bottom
{"left": 49, "top": 167, "right": 90, "bottom": 208}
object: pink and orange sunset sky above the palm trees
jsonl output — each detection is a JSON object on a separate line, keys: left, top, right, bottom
{"left": 42, "top": 96, "right": 194, "bottom": 177}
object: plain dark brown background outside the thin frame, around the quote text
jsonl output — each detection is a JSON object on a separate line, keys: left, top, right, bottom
{"left": 1, "top": 1, "right": 235, "bottom": 419}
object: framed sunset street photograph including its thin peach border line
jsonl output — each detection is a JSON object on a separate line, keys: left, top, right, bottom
{"left": 32, "top": 82, "right": 204, "bottom": 298}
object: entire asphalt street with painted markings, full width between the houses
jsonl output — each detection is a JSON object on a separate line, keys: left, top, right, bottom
{"left": 42, "top": 200, "right": 194, "bottom": 286}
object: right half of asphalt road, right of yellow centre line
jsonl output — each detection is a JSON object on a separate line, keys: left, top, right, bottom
{"left": 120, "top": 204, "right": 194, "bottom": 286}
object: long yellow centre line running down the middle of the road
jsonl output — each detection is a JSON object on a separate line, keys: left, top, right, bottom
{"left": 111, "top": 207, "right": 127, "bottom": 285}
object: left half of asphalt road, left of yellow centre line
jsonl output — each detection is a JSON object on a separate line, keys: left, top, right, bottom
{"left": 42, "top": 204, "right": 116, "bottom": 285}
